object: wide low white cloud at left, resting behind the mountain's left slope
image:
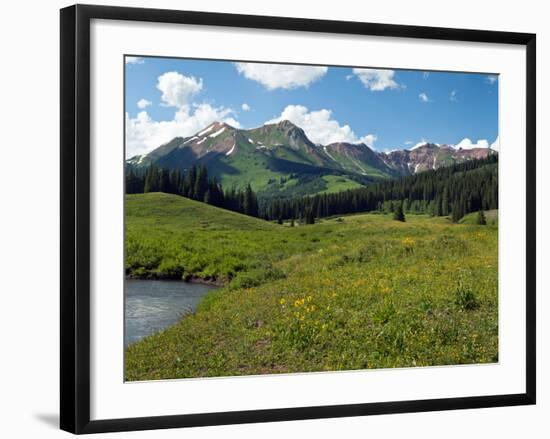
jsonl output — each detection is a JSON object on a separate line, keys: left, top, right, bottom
{"left": 126, "top": 104, "right": 241, "bottom": 158}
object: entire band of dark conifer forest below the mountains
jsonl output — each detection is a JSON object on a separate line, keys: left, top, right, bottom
{"left": 126, "top": 155, "right": 498, "bottom": 224}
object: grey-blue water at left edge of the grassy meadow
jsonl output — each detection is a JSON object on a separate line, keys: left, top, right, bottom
{"left": 124, "top": 279, "right": 216, "bottom": 346}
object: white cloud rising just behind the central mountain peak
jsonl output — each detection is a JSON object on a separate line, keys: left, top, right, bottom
{"left": 266, "top": 105, "right": 376, "bottom": 146}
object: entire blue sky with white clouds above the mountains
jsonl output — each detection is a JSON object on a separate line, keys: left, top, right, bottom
{"left": 125, "top": 57, "right": 498, "bottom": 157}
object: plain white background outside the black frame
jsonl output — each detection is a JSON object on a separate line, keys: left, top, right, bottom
{"left": 0, "top": 0, "right": 550, "bottom": 439}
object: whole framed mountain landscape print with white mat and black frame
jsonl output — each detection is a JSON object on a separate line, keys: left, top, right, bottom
{"left": 61, "top": 5, "right": 536, "bottom": 433}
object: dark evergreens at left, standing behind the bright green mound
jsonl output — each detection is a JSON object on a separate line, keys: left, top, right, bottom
{"left": 126, "top": 165, "right": 258, "bottom": 217}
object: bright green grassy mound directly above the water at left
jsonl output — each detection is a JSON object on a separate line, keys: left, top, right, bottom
{"left": 126, "top": 193, "right": 280, "bottom": 281}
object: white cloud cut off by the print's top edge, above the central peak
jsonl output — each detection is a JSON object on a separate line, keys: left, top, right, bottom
{"left": 235, "top": 62, "right": 328, "bottom": 90}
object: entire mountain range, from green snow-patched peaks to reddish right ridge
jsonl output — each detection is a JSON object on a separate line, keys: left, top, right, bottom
{"left": 126, "top": 120, "right": 496, "bottom": 196}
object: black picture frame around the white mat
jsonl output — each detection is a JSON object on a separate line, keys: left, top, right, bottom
{"left": 60, "top": 5, "right": 536, "bottom": 434}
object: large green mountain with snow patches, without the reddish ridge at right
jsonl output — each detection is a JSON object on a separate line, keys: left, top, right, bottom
{"left": 127, "top": 121, "right": 384, "bottom": 196}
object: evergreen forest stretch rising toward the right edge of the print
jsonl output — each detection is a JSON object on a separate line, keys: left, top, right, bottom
{"left": 260, "top": 156, "right": 498, "bottom": 224}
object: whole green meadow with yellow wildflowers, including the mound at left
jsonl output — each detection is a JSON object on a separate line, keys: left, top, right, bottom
{"left": 126, "top": 194, "right": 498, "bottom": 380}
